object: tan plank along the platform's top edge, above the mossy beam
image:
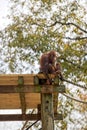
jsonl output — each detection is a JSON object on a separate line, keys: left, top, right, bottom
{"left": 0, "top": 74, "right": 54, "bottom": 86}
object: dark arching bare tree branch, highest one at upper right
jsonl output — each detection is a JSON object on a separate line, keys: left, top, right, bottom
{"left": 48, "top": 21, "right": 87, "bottom": 33}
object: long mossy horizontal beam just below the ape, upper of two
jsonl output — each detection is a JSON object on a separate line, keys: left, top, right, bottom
{"left": 0, "top": 85, "right": 65, "bottom": 93}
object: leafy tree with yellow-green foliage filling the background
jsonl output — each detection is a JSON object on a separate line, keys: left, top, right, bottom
{"left": 0, "top": 0, "right": 87, "bottom": 130}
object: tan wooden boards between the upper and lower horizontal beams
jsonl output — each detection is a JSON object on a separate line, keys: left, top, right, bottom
{"left": 0, "top": 93, "right": 41, "bottom": 109}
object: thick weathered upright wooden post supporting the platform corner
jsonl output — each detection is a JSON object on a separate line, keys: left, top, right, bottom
{"left": 41, "top": 92, "right": 54, "bottom": 130}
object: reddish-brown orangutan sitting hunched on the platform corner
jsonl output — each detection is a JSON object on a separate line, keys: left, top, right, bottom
{"left": 40, "top": 50, "right": 63, "bottom": 79}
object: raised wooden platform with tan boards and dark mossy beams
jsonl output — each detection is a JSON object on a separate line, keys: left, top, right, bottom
{"left": 0, "top": 74, "right": 65, "bottom": 121}
